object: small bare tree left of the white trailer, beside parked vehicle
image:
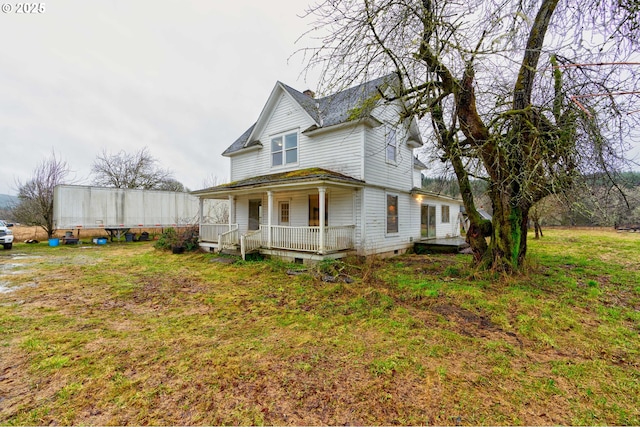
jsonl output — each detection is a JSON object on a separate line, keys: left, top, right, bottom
{"left": 13, "top": 152, "right": 71, "bottom": 238}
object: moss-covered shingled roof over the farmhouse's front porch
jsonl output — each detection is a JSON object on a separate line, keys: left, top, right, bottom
{"left": 191, "top": 168, "right": 365, "bottom": 198}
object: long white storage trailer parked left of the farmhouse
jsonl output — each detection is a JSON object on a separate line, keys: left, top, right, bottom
{"left": 53, "top": 185, "right": 208, "bottom": 241}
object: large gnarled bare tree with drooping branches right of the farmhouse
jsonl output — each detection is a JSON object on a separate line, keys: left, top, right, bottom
{"left": 302, "top": 0, "right": 640, "bottom": 271}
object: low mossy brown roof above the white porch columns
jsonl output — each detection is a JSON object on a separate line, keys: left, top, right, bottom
{"left": 191, "top": 168, "right": 365, "bottom": 195}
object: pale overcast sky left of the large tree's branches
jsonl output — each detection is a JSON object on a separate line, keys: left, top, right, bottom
{"left": 0, "top": 0, "right": 317, "bottom": 194}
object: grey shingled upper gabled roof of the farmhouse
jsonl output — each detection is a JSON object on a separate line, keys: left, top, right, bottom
{"left": 222, "top": 74, "right": 397, "bottom": 156}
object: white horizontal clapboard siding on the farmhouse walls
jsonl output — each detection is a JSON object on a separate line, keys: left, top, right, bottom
{"left": 218, "top": 85, "right": 468, "bottom": 255}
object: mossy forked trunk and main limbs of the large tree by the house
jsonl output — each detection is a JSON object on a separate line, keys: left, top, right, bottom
{"left": 419, "top": 0, "right": 558, "bottom": 271}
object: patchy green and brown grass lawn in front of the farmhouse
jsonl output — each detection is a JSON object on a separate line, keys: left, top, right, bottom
{"left": 0, "top": 230, "right": 640, "bottom": 425}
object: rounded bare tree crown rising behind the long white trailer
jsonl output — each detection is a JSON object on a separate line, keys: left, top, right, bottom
{"left": 91, "top": 147, "right": 175, "bottom": 190}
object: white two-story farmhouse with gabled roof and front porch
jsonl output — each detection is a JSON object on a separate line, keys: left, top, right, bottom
{"left": 193, "top": 76, "right": 460, "bottom": 262}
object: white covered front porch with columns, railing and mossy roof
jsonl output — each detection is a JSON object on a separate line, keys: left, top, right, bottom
{"left": 194, "top": 169, "right": 363, "bottom": 259}
